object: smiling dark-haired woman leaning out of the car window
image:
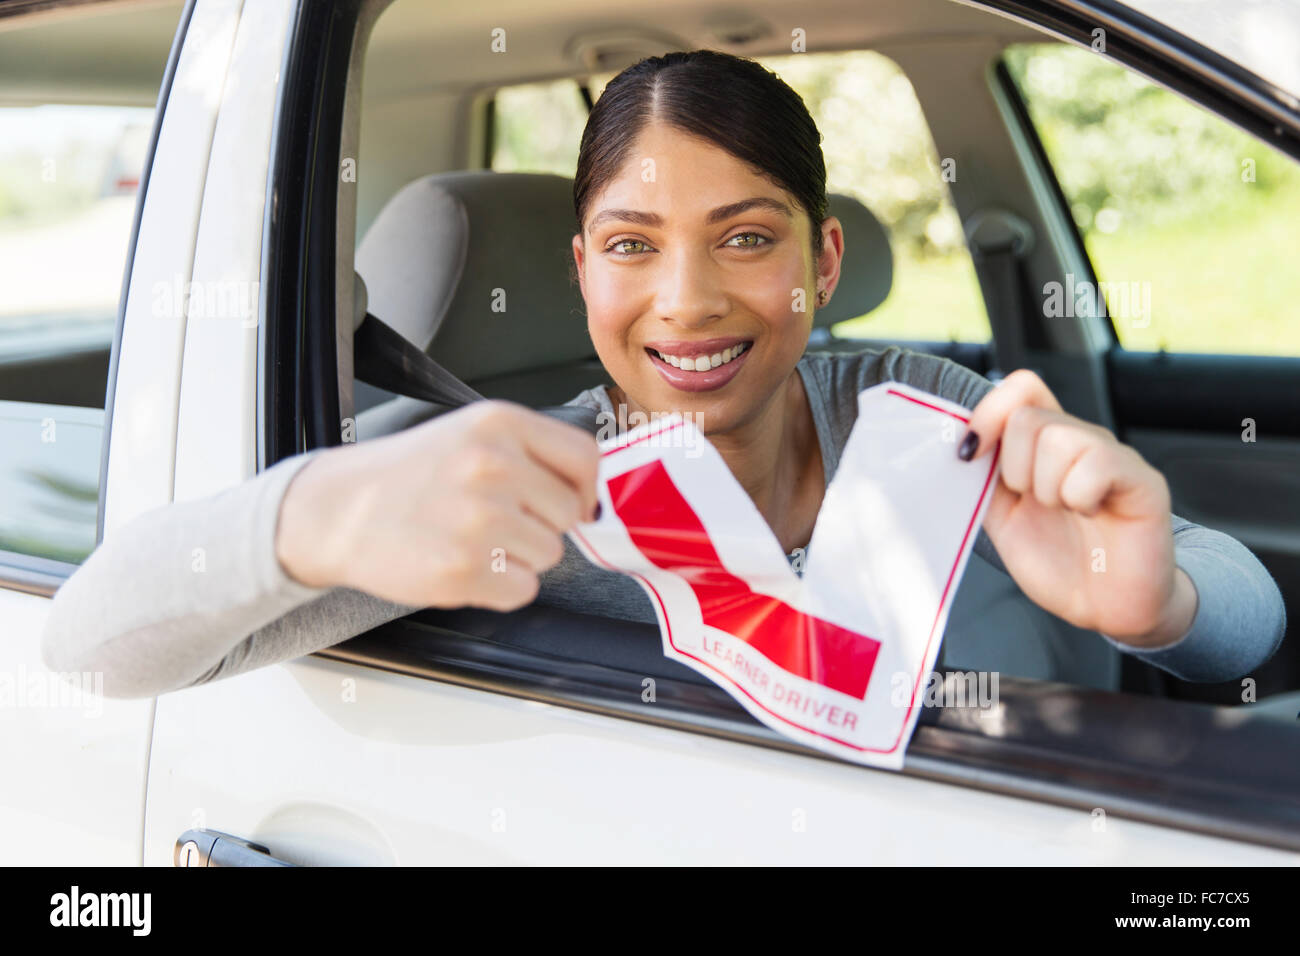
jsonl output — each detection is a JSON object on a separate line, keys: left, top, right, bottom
{"left": 43, "top": 51, "right": 1284, "bottom": 696}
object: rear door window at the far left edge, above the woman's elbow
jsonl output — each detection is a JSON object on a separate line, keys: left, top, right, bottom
{"left": 0, "top": 4, "right": 179, "bottom": 566}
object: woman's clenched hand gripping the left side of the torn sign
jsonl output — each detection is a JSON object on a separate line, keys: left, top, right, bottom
{"left": 276, "top": 401, "right": 599, "bottom": 610}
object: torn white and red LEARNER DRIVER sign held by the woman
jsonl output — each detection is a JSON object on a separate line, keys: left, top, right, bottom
{"left": 571, "top": 382, "right": 998, "bottom": 770}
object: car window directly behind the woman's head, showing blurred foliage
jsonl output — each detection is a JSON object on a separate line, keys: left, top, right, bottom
{"left": 491, "top": 52, "right": 992, "bottom": 342}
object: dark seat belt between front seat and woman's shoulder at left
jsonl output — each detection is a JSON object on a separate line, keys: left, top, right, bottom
{"left": 352, "top": 312, "right": 599, "bottom": 434}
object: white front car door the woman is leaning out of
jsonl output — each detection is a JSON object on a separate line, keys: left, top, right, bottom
{"left": 134, "top": 0, "right": 1300, "bottom": 865}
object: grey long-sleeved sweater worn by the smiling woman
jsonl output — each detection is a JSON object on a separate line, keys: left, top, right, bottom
{"left": 42, "top": 349, "right": 1286, "bottom": 697}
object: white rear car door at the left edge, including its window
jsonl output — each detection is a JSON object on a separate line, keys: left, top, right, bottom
{"left": 0, "top": 3, "right": 189, "bottom": 865}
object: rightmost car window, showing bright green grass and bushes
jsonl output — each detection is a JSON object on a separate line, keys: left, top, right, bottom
{"left": 1006, "top": 43, "right": 1300, "bottom": 355}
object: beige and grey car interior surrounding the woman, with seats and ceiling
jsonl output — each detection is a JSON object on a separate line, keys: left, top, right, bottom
{"left": 0, "top": 0, "right": 1300, "bottom": 721}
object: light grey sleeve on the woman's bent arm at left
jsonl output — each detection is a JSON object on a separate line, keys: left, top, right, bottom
{"left": 42, "top": 450, "right": 417, "bottom": 697}
